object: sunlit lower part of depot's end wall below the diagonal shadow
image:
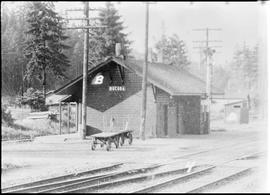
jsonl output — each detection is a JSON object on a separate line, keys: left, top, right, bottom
{"left": 87, "top": 86, "right": 156, "bottom": 137}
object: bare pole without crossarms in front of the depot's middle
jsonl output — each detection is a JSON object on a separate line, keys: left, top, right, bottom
{"left": 140, "top": 2, "right": 149, "bottom": 140}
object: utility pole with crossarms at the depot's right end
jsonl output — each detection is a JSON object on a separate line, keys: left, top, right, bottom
{"left": 194, "top": 28, "right": 221, "bottom": 133}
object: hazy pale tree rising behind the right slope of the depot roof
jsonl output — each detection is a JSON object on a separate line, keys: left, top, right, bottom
{"left": 155, "top": 34, "right": 190, "bottom": 68}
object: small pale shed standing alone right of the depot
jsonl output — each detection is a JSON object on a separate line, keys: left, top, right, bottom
{"left": 225, "top": 100, "right": 249, "bottom": 124}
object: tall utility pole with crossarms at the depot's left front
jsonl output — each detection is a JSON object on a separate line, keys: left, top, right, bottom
{"left": 65, "top": 1, "right": 105, "bottom": 139}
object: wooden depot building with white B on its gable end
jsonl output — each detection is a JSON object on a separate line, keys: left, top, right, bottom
{"left": 48, "top": 57, "right": 223, "bottom": 137}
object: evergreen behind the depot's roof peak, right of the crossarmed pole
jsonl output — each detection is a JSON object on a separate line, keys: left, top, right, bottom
{"left": 89, "top": 2, "right": 131, "bottom": 64}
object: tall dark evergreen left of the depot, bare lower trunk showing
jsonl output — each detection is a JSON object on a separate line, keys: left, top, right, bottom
{"left": 25, "top": 2, "right": 69, "bottom": 98}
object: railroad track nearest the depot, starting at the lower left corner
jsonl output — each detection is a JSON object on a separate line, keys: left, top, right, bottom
{"left": 2, "top": 163, "right": 162, "bottom": 193}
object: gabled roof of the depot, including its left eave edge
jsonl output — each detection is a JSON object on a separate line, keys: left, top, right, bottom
{"left": 55, "top": 57, "right": 223, "bottom": 95}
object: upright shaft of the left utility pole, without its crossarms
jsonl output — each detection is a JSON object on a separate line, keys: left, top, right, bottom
{"left": 80, "top": 2, "right": 89, "bottom": 139}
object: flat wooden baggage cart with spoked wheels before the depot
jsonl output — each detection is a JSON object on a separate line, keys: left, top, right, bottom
{"left": 91, "top": 130, "right": 133, "bottom": 151}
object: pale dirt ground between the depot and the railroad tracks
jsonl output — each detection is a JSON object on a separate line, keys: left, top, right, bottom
{"left": 2, "top": 121, "right": 267, "bottom": 192}
